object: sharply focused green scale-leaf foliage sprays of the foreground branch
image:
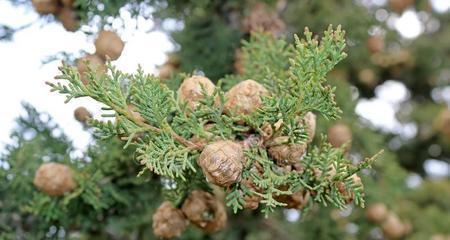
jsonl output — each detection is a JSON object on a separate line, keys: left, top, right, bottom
{"left": 48, "top": 27, "right": 373, "bottom": 218}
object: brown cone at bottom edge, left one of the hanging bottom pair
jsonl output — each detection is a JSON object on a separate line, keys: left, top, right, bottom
{"left": 153, "top": 201, "right": 189, "bottom": 238}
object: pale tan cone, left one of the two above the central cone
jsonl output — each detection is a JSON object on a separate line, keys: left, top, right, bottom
{"left": 178, "top": 76, "right": 215, "bottom": 110}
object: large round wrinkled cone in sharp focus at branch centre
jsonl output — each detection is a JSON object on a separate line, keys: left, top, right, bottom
{"left": 197, "top": 140, "right": 245, "bottom": 187}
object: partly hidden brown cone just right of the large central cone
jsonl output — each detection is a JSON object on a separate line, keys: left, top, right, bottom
{"left": 269, "top": 144, "right": 306, "bottom": 166}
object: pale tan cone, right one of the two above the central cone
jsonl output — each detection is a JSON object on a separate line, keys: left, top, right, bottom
{"left": 224, "top": 79, "right": 269, "bottom": 115}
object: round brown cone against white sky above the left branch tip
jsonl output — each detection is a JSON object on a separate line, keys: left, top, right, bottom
{"left": 94, "top": 30, "right": 125, "bottom": 60}
